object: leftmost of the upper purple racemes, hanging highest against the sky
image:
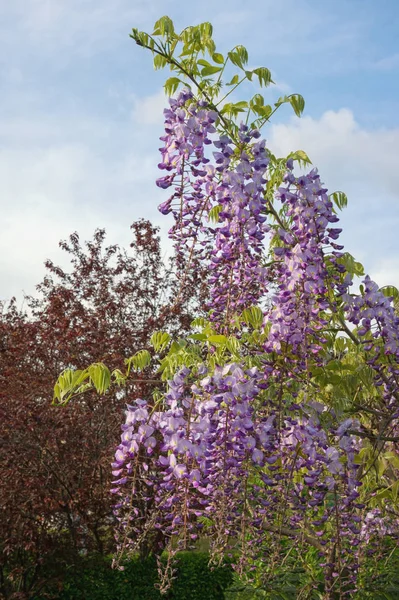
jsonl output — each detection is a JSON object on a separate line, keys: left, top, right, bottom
{"left": 157, "top": 89, "right": 217, "bottom": 302}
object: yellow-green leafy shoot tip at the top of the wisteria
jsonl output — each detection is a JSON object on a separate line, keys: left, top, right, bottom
{"left": 131, "top": 16, "right": 305, "bottom": 135}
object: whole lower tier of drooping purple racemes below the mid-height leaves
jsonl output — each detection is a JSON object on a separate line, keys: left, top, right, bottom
{"left": 112, "top": 364, "right": 368, "bottom": 588}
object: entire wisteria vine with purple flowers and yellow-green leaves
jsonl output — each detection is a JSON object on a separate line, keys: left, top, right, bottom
{"left": 43, "top": 17, "right": 399, "bottom": 600}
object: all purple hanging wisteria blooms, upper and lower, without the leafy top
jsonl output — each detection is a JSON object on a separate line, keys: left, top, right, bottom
{"left": 112, "top": 84, "right": 399, "bottom": 597}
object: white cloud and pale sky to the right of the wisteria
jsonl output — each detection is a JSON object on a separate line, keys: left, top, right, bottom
{"left": 268, "top": 109, "right": 399, "bottom": 284}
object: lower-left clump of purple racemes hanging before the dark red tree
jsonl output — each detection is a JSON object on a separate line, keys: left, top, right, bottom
{"left": 113, "top": 365, "right": 271, "bottom": 560}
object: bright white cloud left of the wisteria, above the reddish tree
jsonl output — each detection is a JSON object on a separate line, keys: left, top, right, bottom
{"left": 0, "top": 117, "right": 166, "bottom": 299}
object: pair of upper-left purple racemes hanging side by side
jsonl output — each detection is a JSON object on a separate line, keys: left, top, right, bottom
{"left": 157, "top": 90, "right": 269, "bottom": 323}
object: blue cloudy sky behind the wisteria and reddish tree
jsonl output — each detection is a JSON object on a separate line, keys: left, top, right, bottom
{"left": 0, "top": 0, "right": 399, "bottom": 300}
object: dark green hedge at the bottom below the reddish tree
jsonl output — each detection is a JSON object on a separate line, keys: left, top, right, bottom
{"left": 34, "top": 552, "right": 233, "bottom": 600}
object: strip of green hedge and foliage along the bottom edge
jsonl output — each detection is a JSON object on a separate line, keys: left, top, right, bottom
{"left": 19, "top": 539, "right": 399, "bottom": 600}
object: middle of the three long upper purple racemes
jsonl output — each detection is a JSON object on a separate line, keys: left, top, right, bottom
{"left": 209, "top": 125, "right": 270, "bottom": 323}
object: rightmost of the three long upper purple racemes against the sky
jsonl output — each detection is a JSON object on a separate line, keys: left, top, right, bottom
{"left": 265, "top": 161, "right": 349, "bottom": 356}
